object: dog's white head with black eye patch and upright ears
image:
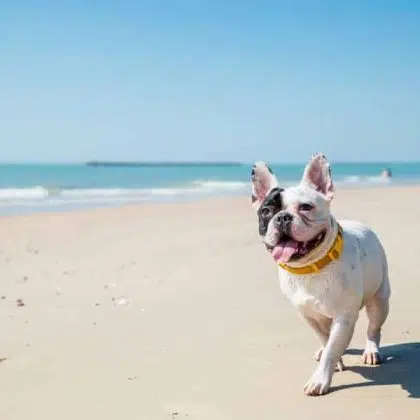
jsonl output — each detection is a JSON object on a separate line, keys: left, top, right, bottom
{"left": 252, "top": 153, "right": 334, "bottom": 263}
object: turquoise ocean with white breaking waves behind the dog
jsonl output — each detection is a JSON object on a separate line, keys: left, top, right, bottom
{"left": 0, "top": 162, "right": 420, "bottom": 215}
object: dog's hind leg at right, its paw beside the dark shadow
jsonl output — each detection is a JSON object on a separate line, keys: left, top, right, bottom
{"left": 363, "top": 278, "right": 390, "bottom": 365}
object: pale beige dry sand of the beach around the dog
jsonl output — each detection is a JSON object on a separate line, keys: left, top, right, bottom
{"left": 0, "top": 187, "right": 420, "bottom": 420}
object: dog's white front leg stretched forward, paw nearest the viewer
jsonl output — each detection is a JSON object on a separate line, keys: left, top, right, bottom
{"left": 305, "top": 312, "right": 358, "bottom": 395}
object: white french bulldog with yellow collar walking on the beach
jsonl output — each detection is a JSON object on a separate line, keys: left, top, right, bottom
{"left": 251, "top": 153, "right": 391, "bottom": 396}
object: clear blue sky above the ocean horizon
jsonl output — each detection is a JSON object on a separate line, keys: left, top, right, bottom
{"left": 0, "top": 0, "right": 420, "bottom": 162}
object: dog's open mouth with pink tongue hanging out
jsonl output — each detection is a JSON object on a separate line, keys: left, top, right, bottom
{"left": 265, "top": 231, "right": 326, "bottom": 263}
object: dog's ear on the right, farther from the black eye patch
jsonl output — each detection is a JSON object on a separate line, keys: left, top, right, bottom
{"left": 301, "top": 153, "right": 334, "bottom": 201}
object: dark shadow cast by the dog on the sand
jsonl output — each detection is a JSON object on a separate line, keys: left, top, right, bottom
{"left": 332, "top": 343, "right": 420, "bottom": 398}
